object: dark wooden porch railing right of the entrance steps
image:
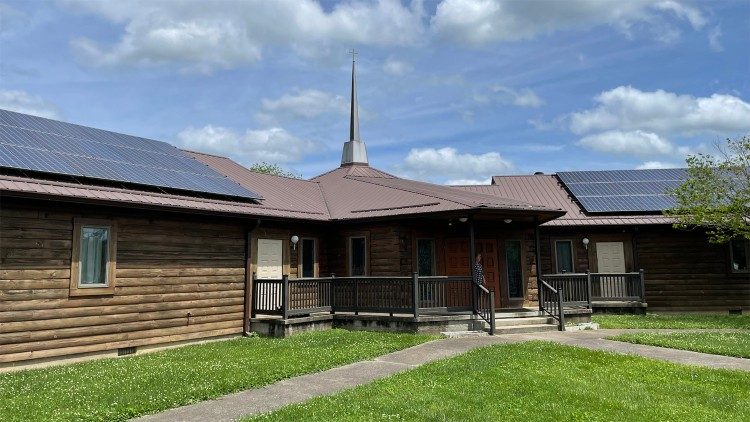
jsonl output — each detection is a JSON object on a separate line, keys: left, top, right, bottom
{"left": 542, "top": 270, "right": 646, "bottom": 308}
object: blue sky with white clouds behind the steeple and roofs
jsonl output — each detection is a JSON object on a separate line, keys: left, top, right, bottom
{"left": 0, "top": 0, "right": 750, "bottom": 183}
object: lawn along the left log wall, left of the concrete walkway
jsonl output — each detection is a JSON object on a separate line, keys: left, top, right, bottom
{"left": 0, "top": 330, "right": 436, "bottom": 422}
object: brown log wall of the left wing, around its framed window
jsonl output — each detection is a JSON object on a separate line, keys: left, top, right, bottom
{"left": 0, "top": 201, "right": 245, "bottom": 365}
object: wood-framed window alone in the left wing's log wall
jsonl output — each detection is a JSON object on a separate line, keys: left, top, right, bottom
{"left": 70, "top": 219, "right": 117, "bottom": 296}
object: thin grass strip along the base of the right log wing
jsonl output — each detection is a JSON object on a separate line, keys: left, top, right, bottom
{"left": 591, "top": 313, "right": 750, "bottom": 330}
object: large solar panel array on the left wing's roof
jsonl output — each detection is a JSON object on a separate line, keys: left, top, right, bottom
{"left": 0, "top": 110, "right": 261, "bottom": 199}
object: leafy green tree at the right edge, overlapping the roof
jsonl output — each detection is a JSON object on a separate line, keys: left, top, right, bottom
{"left": 666, "top": 136, "right": 750, "bottom": 243}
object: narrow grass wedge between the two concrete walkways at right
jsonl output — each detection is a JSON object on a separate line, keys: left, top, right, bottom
{"left": 607, "top": 331, "right": 750, "bottom": 358}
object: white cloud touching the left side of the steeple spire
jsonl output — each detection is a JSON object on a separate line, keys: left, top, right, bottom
{"left": 256, "top": 89, "right": 349, "bottom": 121}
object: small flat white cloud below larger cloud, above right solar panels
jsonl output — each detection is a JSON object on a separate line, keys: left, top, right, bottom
{"left": 577, "top": 130, "right": 688, "bottom": 157}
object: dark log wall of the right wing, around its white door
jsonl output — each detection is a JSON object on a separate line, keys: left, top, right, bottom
{"left": 540, "top": 226, "right": 750, "bottom": 312}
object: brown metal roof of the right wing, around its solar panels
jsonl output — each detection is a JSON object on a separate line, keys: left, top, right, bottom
{"left": 455, "top": 174, "right": 674, "bottom": 226}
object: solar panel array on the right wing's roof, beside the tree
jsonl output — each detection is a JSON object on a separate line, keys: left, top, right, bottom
{"left": 557, "top": 169, "right": 687, "bottom": 213}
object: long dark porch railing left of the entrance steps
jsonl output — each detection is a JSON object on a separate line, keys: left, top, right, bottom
{"left": 252, "top": 273, "right": 495, "bottom": 333}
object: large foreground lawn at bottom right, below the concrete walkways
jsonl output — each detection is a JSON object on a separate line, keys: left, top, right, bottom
{"left": 246, "top": 342, "right": 750, "bottom": 422}
